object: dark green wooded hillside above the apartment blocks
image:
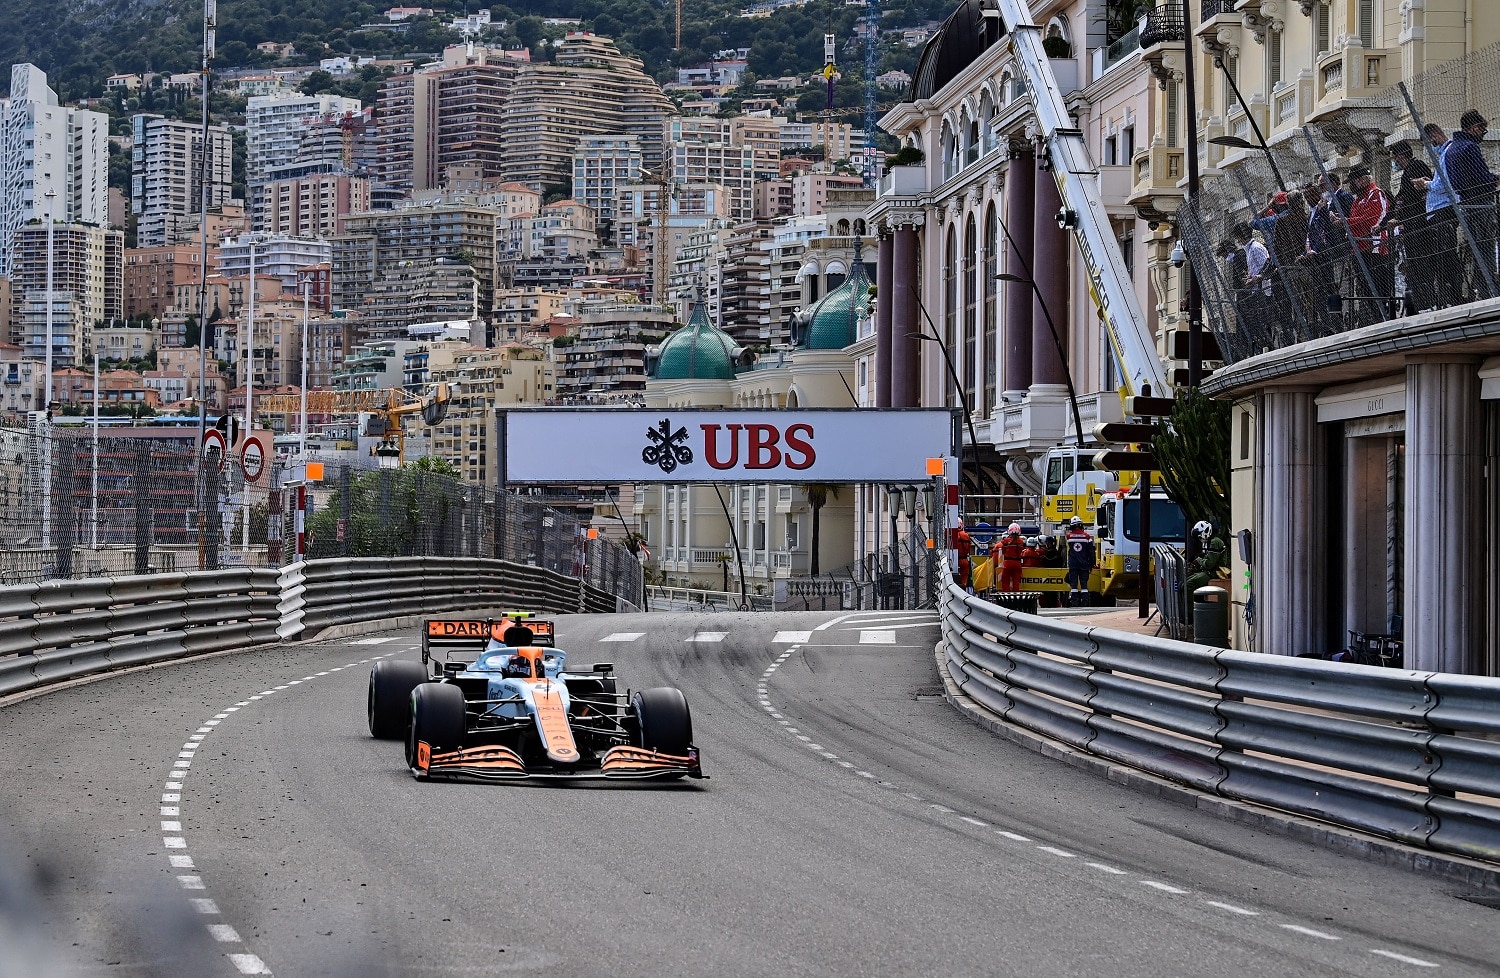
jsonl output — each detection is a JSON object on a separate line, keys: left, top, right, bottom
{"left": 0, "top": 0, "right": 954, "bottom": 101}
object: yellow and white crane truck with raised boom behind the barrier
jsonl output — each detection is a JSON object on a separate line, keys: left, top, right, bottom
{"left": 975, "top": 0, "right": 1187, "bottom": 599}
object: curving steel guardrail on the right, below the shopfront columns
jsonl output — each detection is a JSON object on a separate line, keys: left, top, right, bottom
{"left": 942, "top": 587, "right": 1500, "bottom": 860}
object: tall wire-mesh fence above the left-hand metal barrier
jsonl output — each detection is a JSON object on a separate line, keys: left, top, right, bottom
{"left": 0, "top": 425, "right": 642, "bottom": 602}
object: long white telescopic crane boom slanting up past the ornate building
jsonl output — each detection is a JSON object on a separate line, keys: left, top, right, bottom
{"left": 984, "top": 0, "right": 1170, "bottom": 396}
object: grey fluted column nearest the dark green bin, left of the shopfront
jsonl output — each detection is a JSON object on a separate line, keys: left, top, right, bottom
{"left": 1253, "top": 389, "right": 1334, "bottom": 656}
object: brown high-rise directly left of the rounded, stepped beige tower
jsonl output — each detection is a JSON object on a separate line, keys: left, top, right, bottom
{"left": 375, "top": 45, "right": 527, "bottom": 194}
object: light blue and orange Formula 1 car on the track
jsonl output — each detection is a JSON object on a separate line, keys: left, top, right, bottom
{"left": 368, "top": 612, "right": 707, "bottom": 782}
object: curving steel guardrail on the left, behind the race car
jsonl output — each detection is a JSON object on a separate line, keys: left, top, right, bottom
{"left": 0, "top": 557, "right": 633, "bottom": 696}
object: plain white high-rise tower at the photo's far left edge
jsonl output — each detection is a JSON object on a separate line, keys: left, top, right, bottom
{"left": 0, "top": 65, "right": 110, "bottom": 279}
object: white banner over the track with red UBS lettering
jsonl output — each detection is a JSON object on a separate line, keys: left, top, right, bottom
{"left": 498, "top": 408, "right": 957, "bottom": 485}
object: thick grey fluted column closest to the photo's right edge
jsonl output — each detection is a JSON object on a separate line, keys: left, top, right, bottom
{"left": 1403, "top": 356, "right": 1485, "bottom": 675}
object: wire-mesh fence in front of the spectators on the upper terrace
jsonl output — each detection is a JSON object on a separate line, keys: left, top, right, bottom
{"left": 1179, "top": 45, "right": 1500, "bottom": 363}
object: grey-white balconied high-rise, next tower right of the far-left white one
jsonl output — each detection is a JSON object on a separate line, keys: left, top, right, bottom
{"left": 131, "top": 114, "right": 234, "bottom": 248}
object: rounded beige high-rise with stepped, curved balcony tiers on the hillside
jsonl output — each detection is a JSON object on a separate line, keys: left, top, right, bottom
{"left": 501, "top": 32, "right": 672, "bottom": 189}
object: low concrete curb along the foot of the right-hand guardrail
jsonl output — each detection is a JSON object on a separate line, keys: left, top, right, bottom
{"left": 933, "top": 642, "right": 1500, "bottom": 890}
